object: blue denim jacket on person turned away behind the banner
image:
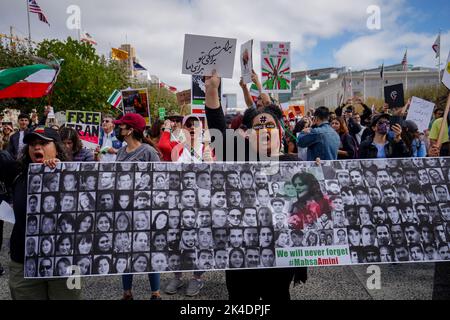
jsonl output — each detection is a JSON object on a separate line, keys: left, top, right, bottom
{"left": 297, "top": 122, "right": 341, "bottom": 161}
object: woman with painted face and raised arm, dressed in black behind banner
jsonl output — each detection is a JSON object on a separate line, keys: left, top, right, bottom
{"left": 205, "top": 71, "right": 307, "bottom": 300}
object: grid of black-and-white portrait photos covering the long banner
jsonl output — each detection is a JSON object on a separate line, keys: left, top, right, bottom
{"left": 25, "top": 158, "right": 450, "bottom": 278}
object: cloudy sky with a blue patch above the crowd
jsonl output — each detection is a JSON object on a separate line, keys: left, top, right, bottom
{"left": 0, "top": 0, "right": 450, "bottom": 105}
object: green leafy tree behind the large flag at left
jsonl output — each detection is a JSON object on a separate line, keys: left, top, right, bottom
{"left": 0, "top": 37, "right": 128, "bottom": 112}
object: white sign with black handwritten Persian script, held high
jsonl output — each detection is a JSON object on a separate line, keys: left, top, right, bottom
{"left": 182, "top": 34, "right": 237, "bottom": 79}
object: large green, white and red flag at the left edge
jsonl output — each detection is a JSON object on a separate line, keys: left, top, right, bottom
{"left": 0, "top": 64, "right": 59, "bottom": 99}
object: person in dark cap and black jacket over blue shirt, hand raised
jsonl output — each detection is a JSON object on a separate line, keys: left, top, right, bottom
{"left": 360, "top": 113, "right": 409, "bottom": 159}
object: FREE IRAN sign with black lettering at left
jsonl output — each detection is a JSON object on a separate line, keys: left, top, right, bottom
{"left": 65, "top": 110, "right": 102, "bottom": 150}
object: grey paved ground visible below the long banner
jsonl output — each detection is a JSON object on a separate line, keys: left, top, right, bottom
{"left": 0, "top": 224, "right": 434, "bottom": 300}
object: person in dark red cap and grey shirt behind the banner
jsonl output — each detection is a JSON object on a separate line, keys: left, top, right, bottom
{"left": 114, "top": 113, "right": 159, "bottom": 162}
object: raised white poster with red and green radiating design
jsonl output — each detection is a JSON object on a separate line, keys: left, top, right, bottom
{"left": 261, "top": 42, "right": 291, "bottom": 93}
